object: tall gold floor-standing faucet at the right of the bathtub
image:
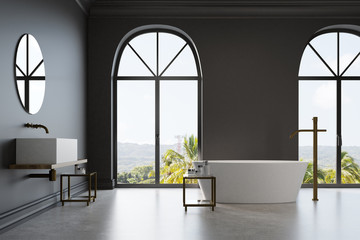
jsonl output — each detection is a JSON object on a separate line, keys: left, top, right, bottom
{"left": 290, "top": 117, "right": 326, "bottom": 201}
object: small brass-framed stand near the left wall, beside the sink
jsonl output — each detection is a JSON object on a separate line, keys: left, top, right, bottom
{"left": 60, "top": 172, "right": 97, "bottom": 206}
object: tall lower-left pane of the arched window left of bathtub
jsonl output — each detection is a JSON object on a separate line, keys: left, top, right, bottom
{"left": 117, "top": 81, "right": 155, "bottom": 184}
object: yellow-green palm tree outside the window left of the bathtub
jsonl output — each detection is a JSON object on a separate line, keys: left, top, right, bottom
{"left": 160, "top": 135, "right": 198, "bottom": 183}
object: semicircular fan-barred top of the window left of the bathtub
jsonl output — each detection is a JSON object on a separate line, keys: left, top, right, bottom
{"left": 115, "top": 25, "right": 201, "bottom": 78}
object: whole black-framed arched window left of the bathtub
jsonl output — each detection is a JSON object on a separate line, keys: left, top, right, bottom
{"left": 113, "top": 25, "right": 202, "bottom": 186}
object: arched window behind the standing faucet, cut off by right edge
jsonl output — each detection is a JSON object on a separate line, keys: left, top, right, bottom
{"left": 299, "top": 25, "right": 360, "bottom": 186}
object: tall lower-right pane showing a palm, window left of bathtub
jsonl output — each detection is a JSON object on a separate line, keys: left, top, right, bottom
{"left": 160, "top": 81, "right": 198, "bottom": 183}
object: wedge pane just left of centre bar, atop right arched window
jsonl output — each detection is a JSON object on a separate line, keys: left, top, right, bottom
{"left": 310, "top": 33, "right": 337, "bottom": 74}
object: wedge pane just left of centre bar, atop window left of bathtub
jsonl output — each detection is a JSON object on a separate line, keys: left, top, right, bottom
{"left": 129, "top": 33, "right": 156, "bottom": 74}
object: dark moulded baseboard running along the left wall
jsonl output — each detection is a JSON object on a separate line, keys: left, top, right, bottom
{"left": 0, "top": 181, "right": 88, "bottom": 234}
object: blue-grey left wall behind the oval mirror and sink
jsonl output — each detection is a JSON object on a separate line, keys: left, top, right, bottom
{"left": 0, "top": 0, "right": 87, "bottom": 229}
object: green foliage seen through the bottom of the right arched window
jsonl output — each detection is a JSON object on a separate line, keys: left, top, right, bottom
{"left": 300, "top": 152, "right": 360, "bottom": 183}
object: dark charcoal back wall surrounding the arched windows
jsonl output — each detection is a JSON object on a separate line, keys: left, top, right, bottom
{"left": 88, "top": 4, "right": 360, "bottom": 187}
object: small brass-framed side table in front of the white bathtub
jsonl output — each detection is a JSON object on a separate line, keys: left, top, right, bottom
{"left": 183, "top": 174, "right": 216, "bottom": 212}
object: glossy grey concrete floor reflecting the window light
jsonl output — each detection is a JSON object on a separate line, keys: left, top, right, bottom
{"left": 0, "top": 189, "right": 360, "bottom": 240}
